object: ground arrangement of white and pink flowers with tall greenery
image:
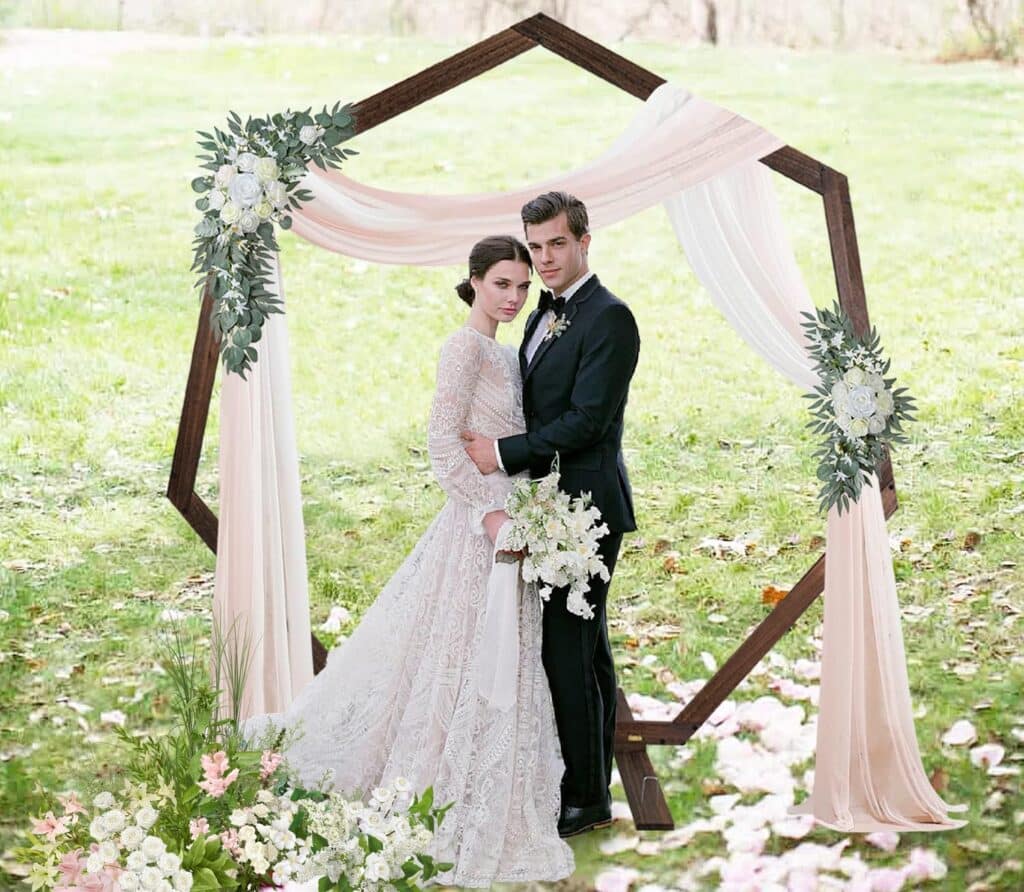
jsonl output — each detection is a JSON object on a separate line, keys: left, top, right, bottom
{"left": 15, "top": 635, "right": 452, "bottom": 892}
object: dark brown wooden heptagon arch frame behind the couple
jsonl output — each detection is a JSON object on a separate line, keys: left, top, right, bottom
{"left": 167, "top": 13, "right": 897, "bottom": 830}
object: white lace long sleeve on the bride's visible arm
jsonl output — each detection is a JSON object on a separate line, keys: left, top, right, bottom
{"left": 427, "top": 330, "right": 505, "bottom": 534}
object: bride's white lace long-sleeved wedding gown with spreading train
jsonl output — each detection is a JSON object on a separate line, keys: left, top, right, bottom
{"left": 243, "top": 326, "right": 574, "bottom": 887}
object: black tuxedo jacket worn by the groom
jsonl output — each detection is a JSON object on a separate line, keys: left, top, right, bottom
{"left": 498, "top": 275, "right": 640, "bottom": 533}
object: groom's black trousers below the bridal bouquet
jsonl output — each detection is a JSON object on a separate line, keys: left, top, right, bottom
{"left": 542, "top": 533, "right": 623, "bottom": 806}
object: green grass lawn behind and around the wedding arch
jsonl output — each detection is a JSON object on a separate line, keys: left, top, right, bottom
{"left": 0, "top": 29, "right": 1024, "bottom": 890}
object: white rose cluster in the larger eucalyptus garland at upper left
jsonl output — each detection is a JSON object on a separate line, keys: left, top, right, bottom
{"left": 207, "top": 152, "right": 288, "bottom": 233}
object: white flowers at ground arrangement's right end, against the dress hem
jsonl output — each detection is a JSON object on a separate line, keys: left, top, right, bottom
{"left": 297, "top": 777, "right": 433, "bottom": 890}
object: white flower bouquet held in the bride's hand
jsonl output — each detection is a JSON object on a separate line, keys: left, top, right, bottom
{"left": 505, "top": 455, "right": 610, "bottom": 620}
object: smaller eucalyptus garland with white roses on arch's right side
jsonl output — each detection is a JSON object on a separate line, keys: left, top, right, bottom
{"left": 801, "top": 303, "right": 916, "bottom": 514}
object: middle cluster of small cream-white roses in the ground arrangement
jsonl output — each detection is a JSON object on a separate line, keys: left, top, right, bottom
{"left": 229, "top": 790, "right": 309, "bottom": 886}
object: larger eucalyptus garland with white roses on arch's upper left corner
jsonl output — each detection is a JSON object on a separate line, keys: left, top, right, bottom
{"left": 191, "top": 103, "right": 356, "bottom": 378}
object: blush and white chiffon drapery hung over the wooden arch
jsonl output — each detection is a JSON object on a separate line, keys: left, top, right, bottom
{"left": 215, "top": 84, "right": 965, "bottom": 833}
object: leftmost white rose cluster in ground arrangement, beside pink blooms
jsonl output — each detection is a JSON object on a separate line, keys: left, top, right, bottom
{"left": 85, "top": 792, "right": 193, "bottom": 892}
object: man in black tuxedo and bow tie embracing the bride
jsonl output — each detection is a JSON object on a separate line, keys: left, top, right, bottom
{"left": 465, "top": 192, "right": 640, "bottom": 837}
